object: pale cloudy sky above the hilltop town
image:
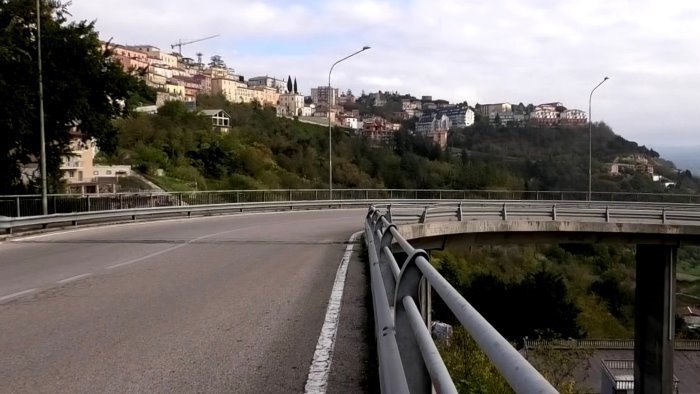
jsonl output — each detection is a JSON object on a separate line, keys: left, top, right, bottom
{"left": 69, "top": 0, "right": 700, "bottom": 149}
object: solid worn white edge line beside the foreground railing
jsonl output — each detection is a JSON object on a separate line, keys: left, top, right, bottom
{"left": 304, "top": 231, "right": 362, "bottom": 394}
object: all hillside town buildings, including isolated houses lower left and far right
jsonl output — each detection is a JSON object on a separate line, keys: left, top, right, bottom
{"left": 53, "top": 42, "right": 673, "bottom": 194}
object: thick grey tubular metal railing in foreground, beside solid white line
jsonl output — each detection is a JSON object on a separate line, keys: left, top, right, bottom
{"left": 365, "top": 207, "right": 557, "bottom": 393}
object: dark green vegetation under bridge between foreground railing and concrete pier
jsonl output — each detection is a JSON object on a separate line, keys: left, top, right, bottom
{"left": 433, "top": 245, "right": 635, "bottom": 343}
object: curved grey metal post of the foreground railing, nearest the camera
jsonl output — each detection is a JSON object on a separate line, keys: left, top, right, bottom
{"left": 394, "top": 249, "right": 432, "bottom": 393}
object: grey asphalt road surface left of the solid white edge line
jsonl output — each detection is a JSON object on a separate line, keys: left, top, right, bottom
{"left": 0, "top": 210, "right": 365, "bottom": 393}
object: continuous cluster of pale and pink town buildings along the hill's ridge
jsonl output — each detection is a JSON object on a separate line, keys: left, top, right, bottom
{"left": 109, "top": 43, "right": 587, "bottom": 149}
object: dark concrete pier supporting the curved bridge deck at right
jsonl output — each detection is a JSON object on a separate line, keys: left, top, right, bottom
{"left": 634, "top": 244, "right": 678, "bottom": 394}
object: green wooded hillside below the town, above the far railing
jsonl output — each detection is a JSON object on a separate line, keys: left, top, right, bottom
{"left": 102, "top": 96, "right": 699, "bottom": 192}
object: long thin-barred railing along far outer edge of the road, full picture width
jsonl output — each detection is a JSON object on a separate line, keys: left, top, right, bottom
{"left": 0, "top": 189, "right": 700, "bottom": 217}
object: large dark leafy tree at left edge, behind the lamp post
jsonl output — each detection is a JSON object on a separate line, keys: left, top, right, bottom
{"left": 0, "top": 0, "right": 153, "bottom": 193}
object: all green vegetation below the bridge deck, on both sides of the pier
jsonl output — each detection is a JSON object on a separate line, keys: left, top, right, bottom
{"left": 432, "top": 244, "right": 700, "bottom": 393}
